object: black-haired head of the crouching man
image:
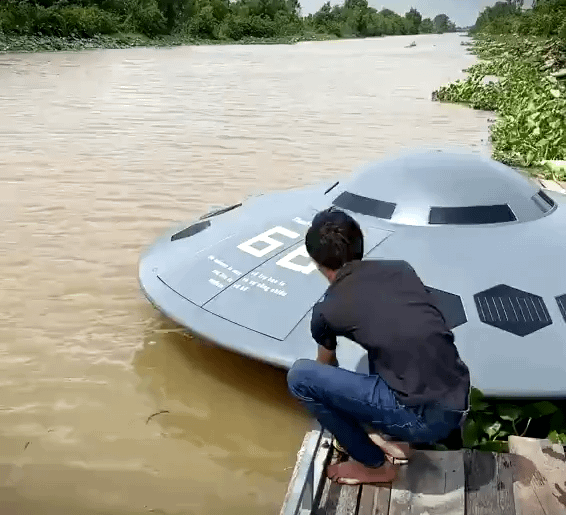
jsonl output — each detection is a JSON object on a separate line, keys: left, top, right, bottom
{"left": 305, "top": 208, "right": 364, "bottom": 282}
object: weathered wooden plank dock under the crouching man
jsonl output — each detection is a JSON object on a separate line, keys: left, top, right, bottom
{"left": 281, "top": 427, "right": 566, "bottom": 515}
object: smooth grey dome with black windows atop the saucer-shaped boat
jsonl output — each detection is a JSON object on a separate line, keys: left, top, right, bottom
{"left": 333, "top": 151, "right": 556, "bottom": 226}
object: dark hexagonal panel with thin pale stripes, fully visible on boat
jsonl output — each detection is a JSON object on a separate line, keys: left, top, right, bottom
{"left": 474, "top": 284, "right": 552, "bottom": 336}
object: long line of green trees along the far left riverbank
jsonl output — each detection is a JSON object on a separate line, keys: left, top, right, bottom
{"left": 0, "top": 0, "right": 457, "bottom": 41}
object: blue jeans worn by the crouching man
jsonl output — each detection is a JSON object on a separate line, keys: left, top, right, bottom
{"left": 287, "top": 359, "right": 466, "bottom": 467}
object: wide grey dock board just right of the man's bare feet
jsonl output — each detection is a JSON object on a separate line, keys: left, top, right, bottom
{"left": 389, "top": 451, "right": 465, "bottom": 515}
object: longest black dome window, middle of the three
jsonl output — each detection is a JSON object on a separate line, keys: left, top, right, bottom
{"left": 428, "top": 204, "right": 517, "bottom": 225}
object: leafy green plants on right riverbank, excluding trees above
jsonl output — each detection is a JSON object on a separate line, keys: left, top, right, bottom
{"left": 433, "top": 34, "right": 566, "bottom": 180}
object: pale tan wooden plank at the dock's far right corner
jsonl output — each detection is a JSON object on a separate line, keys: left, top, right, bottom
{"left": 509, "top": 436, "right": 566, "bottom": 515}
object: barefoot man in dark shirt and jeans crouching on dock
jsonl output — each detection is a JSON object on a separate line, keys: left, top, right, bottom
{"left": 287, "top": 208, "right": 470, "bottom": 484}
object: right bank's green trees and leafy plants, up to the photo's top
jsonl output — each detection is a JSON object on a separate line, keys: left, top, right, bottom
{"left": 433, "top": 0, "right": 566, "bottom": 179}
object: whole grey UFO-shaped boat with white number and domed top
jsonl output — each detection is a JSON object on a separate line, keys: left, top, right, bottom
{"left": 139, "top": 150, "right": 566, "bottom": 398}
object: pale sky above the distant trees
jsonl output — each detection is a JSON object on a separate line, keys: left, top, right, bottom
{"left": 299, "top": 0, "right": 500, "bottom": 27}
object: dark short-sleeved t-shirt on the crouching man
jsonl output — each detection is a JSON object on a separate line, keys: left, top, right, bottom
{"left": 311, "top": 260, "right": 470, "bottom": 409}
